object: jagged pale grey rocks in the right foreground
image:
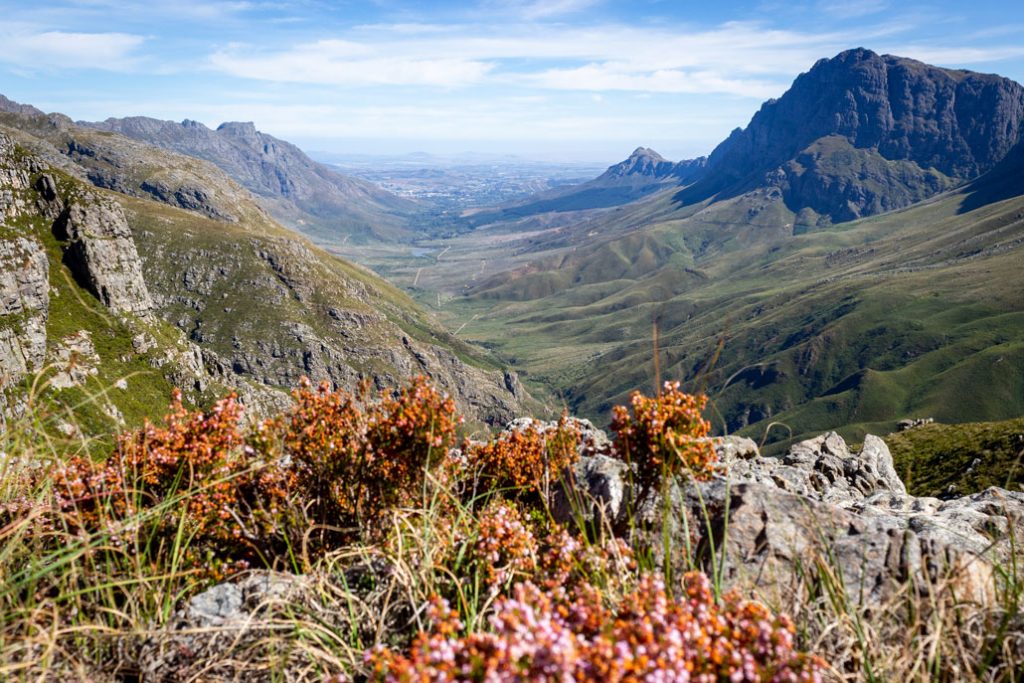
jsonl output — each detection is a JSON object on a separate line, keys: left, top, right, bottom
{"left": 554, "top": 432, "right": 1024, "bottom": 603}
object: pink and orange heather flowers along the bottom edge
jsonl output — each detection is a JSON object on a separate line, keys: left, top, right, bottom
{"left": 367, "top": 572, "right": 823, "bottom": 683}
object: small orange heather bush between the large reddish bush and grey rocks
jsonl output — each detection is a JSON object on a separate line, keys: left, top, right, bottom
{"left": 468, "top": 415, "right": 580, "bottom": 495}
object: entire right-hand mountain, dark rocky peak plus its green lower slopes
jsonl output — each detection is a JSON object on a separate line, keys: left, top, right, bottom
{"left": 354, "top": 50, "right": 1024, "bottom": 446}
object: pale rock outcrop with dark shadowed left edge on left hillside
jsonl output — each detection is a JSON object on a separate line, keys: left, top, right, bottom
{"left": 54, "top": 193, "right": 153, "bottom": 314}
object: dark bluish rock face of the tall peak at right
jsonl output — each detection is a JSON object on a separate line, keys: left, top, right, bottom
{"left": 679, "top": 48, "right": 1024, "bottom": 221}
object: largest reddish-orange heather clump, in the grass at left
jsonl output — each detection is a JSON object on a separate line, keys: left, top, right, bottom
{"left": 46, "top": 378, "right": 459, "bottom": 577}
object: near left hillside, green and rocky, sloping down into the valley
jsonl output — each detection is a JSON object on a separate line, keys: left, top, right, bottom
{"left": 0, "top": 101, "right": 528, "bottom": 433}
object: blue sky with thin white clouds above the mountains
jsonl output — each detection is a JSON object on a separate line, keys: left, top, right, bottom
{"left": 0, "top": 0, "right": 1024, "bottom": 163}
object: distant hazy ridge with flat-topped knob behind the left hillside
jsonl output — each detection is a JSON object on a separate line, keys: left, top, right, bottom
{"left": 79, "top": 112, "right": 419, "bottom": 243}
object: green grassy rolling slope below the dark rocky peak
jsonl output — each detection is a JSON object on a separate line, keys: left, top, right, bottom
{"left": 366, "top": 180, "right": 1024, "bottom": 439}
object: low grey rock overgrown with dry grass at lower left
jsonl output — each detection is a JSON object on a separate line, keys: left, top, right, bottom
{"left": 136, "top": 557, "right": 415, "bottom": 683}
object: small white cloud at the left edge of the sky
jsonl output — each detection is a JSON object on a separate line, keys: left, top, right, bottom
{"left": 0, "top": 30, "right": 145, "bottom": 71}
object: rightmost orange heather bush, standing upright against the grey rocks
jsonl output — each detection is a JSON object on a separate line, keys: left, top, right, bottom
{"left": 611, "top": 382, "right": 717, "bottom": 500}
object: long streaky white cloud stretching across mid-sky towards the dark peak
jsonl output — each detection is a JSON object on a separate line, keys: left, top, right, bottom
{"left": 203, "top": 23, "right": 860, "bottom": 98}
